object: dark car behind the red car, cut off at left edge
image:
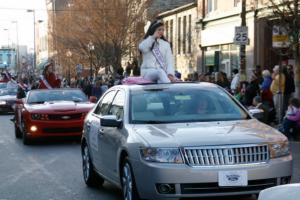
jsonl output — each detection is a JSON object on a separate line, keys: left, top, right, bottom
{"left": 0, "top": 88, "right": 18, "bottom": 113}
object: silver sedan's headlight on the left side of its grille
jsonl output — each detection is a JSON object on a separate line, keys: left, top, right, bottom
{"left": 140, "top": 148, "right": 183, "bottom": 164}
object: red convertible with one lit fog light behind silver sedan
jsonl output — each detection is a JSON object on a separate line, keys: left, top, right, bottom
{"left": 15, "top": 89, "right": 94, "bottom": 144}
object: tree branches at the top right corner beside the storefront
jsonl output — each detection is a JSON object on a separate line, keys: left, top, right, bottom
{"left": 269, "top": 0, "right": 300, "bottom": 98}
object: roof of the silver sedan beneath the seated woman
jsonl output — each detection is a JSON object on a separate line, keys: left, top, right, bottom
{"left": 114, "top": 82, "right": 220, "bottom": 91}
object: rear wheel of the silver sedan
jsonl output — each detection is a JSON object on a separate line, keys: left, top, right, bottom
{"left": 81, "top": 144, "right": 104, "bottom": 187}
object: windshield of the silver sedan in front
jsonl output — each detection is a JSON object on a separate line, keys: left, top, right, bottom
{"left": 130, "top": 88, "right": 249, "bottom": 124}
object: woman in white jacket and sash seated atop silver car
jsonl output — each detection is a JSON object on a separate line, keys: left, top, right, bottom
{"left": 139, "top": 20, "right": 175, "bottom": 83}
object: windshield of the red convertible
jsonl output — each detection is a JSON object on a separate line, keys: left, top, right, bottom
{"left": 27, "top": 90, "right": 88, "bottom": 104}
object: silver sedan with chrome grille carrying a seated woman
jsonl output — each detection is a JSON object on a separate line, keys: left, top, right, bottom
{"left": 81, "top": 83, "right": 293, "bottom": 200}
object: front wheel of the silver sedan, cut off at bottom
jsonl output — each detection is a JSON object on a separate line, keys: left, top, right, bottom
{"left": 121, "top": 158, "right": 140, "bottom": 200}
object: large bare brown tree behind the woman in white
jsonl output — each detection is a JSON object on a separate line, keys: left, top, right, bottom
{"left": 53, "top": 0, "right": 150, "bottom": 77}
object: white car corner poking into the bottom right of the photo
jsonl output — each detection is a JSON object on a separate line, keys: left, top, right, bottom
{"left": 258, "top": 183, "right": 300, "bottom": 200}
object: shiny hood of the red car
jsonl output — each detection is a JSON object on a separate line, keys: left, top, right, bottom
{"left": 25, "top": 101, "right": 95, "bottom": 113}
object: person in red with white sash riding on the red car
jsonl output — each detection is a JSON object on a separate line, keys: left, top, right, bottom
{"left": 39, "top": 62, "right": 61, "bottom": 89}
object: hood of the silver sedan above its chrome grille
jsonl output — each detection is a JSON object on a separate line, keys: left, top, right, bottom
{"left": 133, "top": 119, "right": 286, "bottom": 147}
